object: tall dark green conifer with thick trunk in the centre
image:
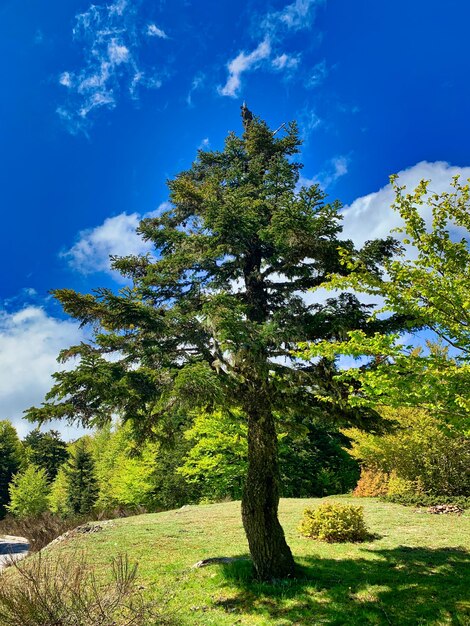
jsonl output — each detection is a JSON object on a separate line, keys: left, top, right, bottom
{"left": 28, "top": 110, "right": 400, "bottom": 579}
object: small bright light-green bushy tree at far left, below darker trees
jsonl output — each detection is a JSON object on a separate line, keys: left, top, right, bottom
{"left": 6, "top": 465, "right": 49, "bottom": 518}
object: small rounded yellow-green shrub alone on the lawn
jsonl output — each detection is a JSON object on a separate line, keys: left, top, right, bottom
{"left": 299, "top": 502, "right": 370, "bottom": 543}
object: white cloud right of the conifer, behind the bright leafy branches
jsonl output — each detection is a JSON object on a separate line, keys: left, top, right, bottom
{"left": 343, "top": 161, "right": 470, "bottom": 246}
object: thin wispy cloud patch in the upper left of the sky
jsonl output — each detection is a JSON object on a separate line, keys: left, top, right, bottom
{"left": 57, "top": 0, "right": 167, "bottom": 133}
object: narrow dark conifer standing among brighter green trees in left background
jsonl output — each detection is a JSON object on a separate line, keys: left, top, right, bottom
{"left": 64, "top": 439, "right": 98, "bottom": 515}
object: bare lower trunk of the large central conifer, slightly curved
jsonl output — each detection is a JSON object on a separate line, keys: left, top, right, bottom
{"left": 242, "top": 410, "right": 295, "bottom": 580}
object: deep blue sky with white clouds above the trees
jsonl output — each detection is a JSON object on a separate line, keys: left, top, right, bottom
{"left": 0, "top": 0, "right": 470, "bottom": 436}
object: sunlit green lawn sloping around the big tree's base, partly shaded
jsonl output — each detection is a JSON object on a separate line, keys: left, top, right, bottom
{"left": 46, "top": 497, "right": 470, "bottom": 626}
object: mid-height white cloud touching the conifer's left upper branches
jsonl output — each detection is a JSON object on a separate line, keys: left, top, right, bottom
{"left": 61, "top": 202, "right": 169, "bottom": 278}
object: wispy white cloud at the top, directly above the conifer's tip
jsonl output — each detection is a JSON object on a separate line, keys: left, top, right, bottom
{"left": 218, "top": 0, "right": 325, "bottom": 98}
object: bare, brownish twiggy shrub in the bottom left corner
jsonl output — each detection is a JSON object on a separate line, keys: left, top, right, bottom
{"left": 0, "top": 554, "right": 171, "bottom": 626}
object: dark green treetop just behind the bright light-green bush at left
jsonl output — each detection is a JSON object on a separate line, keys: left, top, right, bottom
{"left": 23, "top": 428, "right": 68, "bottom": 482}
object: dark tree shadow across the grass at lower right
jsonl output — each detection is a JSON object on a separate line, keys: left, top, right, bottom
{"left": 214, "top": 547, "right": 470, "bottom": 626}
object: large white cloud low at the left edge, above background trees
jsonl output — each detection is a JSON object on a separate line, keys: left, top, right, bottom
{"left": 0, "top": 306, "right": 85, "bottom": 438}
